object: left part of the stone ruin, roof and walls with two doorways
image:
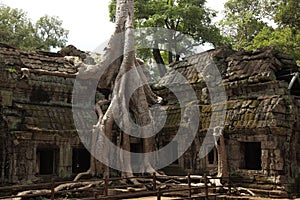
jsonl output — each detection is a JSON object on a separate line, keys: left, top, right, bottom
{"left": 0, "top": 44, "right": 89, "bottom": 183}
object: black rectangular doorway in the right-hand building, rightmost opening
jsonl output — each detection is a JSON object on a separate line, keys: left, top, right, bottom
{"left": 241, "top": 142, "right": 261, "bottom": 170}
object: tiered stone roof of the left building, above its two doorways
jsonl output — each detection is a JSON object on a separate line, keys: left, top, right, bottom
{"left": 0, "top": 44, "right": 83, "bottom": 133}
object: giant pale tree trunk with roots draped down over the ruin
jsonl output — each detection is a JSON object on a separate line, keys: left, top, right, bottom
{"left": 76, "top": 0, "right": 161, "bottom": 180}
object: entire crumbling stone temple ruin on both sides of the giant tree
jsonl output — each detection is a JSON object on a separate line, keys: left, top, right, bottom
{"left": 0, "top": 44, "right": 300, "bottom": 192}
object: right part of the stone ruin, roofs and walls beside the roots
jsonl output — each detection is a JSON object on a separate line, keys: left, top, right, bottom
{"left": 156, "top": 48, "right": 300, "bottom": 191}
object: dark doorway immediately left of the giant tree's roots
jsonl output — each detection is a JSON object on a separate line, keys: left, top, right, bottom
{"left": 72, "top": 148, "right": 91, "bottom": 174}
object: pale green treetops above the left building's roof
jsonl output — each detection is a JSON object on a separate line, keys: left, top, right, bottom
{"left": 0, "top": 4, "right": 68, "bottom": 51}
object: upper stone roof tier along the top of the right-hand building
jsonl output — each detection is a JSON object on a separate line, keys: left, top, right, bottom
{"left": 159, "top": 48, "right": 298, "bottom": 85}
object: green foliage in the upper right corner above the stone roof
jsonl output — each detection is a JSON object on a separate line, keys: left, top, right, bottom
{"left": 220, "top": 0, "right": 300, "bottom": 63}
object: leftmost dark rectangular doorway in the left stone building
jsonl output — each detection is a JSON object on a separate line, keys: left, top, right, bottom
{"left": 37, "top": 149, "right": 57, "bottom": 175}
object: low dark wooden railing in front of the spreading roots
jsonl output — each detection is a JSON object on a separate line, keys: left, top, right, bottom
{"left": 0, "top": 173, "right": 292, "bottom": 200}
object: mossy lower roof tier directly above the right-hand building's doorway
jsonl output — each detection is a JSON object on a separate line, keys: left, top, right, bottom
{"left": 201, "top": 95, "right": 298, "bottom": 134}
